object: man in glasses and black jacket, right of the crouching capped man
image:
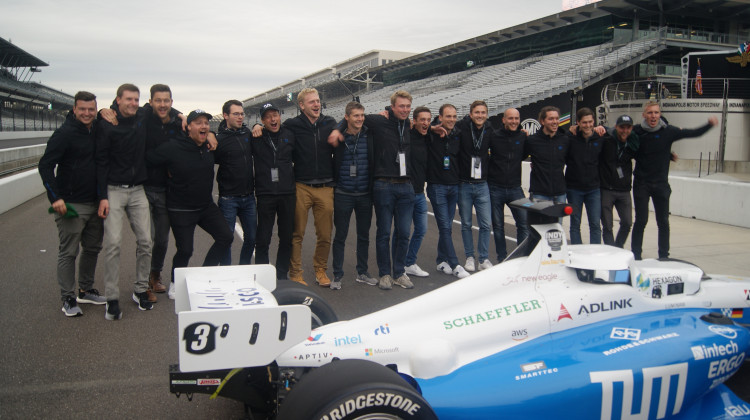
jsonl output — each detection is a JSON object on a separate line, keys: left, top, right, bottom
{"left": 215, "top": 99, "right": 258, "bottom": 265}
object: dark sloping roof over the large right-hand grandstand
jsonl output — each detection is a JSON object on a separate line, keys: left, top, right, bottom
{"left": 379, "top": 0, "right": 750, "bottom": 72}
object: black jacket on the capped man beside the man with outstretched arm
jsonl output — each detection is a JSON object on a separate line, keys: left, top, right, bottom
{"left": 599, "top": 129, "right": 638, "bottom": 192}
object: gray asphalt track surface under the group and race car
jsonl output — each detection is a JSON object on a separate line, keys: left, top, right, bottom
{"left": 0, "top": 192, "right": 750, "bottom": 419}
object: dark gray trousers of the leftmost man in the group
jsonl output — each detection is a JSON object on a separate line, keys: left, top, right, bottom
{"left": 55, "top": 203, "right": 103, "bottom": 301}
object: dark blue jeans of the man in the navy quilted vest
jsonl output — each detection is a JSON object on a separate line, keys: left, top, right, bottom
{"left": 332, "top": 192, "right": 372, "bottom": 279}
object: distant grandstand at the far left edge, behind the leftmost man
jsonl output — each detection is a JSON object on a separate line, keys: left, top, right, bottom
{"left": 0, "top": 38, "right": 73, "bottom": 131}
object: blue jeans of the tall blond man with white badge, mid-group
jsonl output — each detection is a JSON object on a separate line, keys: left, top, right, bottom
{"left": 372, "top": 180, "right": 414, "bottom": 277}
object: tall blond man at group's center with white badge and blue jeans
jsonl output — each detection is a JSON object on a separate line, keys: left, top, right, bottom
{"left": 328, "top": 90, "right": 414, "bottom": 290}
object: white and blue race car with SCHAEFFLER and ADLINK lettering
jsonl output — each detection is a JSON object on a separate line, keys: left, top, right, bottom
{"left": 170, "top": 199, "right": 750, "bottom": 420}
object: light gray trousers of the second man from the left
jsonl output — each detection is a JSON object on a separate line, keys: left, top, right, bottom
{"left": 103, "top": 185, "right": 151, "bottom": 300}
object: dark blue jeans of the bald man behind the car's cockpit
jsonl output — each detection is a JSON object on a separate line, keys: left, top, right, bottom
{"left": 490, "top": 184, "right": 529, "bottom": 262}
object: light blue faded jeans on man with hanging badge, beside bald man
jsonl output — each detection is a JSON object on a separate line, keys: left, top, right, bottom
{"left": 458, "top": 182, "right": 492, "bottom": 263}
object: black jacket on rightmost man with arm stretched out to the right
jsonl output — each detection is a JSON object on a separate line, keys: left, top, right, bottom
{"left": 633, "top": 124, "right": 711, "bottom": 184}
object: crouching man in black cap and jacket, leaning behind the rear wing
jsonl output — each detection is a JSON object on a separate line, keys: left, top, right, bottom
{"left": 148, "top": 109, "right": 232, "bottom": 283}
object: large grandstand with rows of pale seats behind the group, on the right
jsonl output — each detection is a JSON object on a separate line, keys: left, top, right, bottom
{"left": 243, "top": 0, "right": 750, "bottom": 172}
